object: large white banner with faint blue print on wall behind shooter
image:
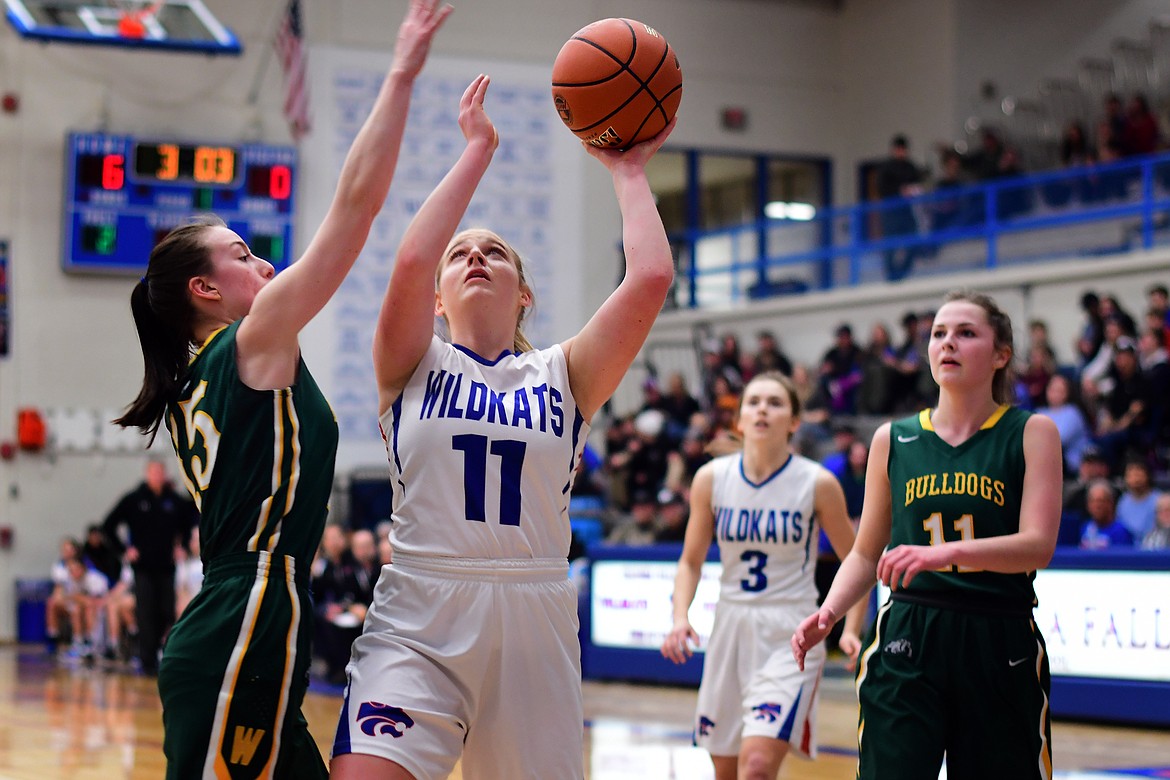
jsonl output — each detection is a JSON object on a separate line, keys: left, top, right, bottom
{"left": 297, "top": 47, "right": 589, "bottom": 453}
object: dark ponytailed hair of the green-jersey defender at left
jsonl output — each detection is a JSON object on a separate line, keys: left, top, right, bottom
{"left": 113, "top": 216, "right": 223, "bottom": 442}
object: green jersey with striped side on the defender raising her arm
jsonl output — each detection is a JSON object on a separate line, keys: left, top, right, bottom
{"left": 166, "top": 320, "right": 337, "bottom": 566}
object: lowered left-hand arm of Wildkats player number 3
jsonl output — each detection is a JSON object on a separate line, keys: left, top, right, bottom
{"left": 662, "top": 463, "right": 715, "bottom": 663}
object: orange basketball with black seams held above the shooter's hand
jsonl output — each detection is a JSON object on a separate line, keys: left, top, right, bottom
{"left": 552, "top": 19, "right": 682, "bottom": 150}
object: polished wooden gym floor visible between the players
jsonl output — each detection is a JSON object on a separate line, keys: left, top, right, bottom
{"left": 0, "top": 646, "right": 1170, "bottom": 780}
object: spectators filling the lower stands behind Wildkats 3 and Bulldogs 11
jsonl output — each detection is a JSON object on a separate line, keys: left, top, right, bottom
{"left": 582, "top": 284, "right": 1170, "bottom": 555}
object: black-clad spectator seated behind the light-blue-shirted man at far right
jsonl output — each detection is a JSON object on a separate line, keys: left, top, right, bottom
{"left": 1096, "top": 337, "right": 1165, "bottom": 463}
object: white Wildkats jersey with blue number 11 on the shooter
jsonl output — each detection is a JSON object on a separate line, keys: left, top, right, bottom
{"left": 379, "top": 337, "right": 589, "bottom": 559}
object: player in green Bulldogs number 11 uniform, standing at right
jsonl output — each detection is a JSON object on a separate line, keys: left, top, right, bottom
{"left": 792, "top": 292, "right": 1061, "bottom": 780}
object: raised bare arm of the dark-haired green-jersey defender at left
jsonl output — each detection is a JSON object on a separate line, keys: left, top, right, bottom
{"left": 238, "top": 0, "right": 452, "bottom": 360}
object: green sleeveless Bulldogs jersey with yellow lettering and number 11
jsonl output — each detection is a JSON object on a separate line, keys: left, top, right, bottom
{"left": 888, "top": 406, "right": 1035, "bottom": 608}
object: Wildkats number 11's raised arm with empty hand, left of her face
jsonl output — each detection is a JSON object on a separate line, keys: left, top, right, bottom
{"left": 373, "top": 74, "right": 500, "bottom": 415}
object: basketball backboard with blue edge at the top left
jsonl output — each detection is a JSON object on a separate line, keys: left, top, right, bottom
{"left": 5, "top": 0, "right": 242, "bottom": 54}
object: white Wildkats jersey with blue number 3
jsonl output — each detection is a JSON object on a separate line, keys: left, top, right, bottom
{"left": 711, "top": 454, "right": 821, "bottom": 608}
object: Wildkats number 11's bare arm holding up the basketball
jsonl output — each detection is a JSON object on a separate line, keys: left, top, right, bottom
{"left": 562, "top": 120, "right": 676, "bottom": 420}
